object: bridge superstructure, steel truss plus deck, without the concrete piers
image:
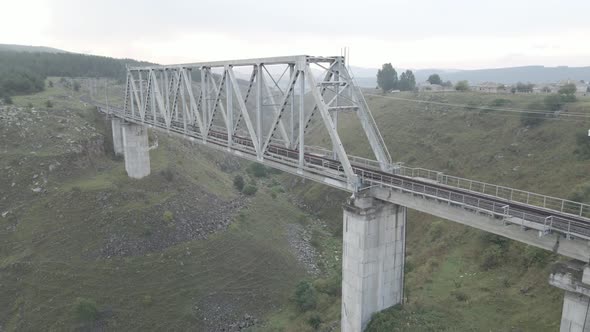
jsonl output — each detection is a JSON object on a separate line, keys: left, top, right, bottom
{"left": 104, "top": 56, "right": 590, "bottom": 246}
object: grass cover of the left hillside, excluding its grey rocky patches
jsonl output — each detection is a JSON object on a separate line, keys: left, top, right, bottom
{"left": 0, "top": 82, "right": 320, "bottom": 331}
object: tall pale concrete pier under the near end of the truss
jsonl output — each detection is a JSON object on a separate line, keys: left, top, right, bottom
{"left": 341, "top": 197, "right": 406, "bottom": 332}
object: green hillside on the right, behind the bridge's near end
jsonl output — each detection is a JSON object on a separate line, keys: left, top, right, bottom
{"left": 284, "top": 93, "right": 590, "bottom": 331}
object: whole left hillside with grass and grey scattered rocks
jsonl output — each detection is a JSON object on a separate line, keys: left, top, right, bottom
{"left": 0, "top": 84, "right": 338, "bottom": 331}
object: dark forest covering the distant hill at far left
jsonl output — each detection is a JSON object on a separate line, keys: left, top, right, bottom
{"left": 0, "top": 51, "right": 153, "bottom": 98}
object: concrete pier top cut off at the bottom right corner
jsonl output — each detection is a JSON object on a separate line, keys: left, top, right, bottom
{"left": 549, "top": 261, "right": 590, "bottom": 332}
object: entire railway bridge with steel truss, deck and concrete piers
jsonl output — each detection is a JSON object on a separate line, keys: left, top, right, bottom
{"left": 95, "top": 55, "right": 590, "bottom": 332}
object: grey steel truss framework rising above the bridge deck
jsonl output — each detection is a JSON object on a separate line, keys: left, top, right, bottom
{"left": 124, "top": 55, "right": 391, "bottom": 190}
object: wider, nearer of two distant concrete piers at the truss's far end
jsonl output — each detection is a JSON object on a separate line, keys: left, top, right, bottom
{"left": 122, "top": 123, "right": 150, "bottom": 179}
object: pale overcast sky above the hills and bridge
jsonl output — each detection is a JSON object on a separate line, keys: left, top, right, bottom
{"left": 0, "top": 0, "right": 590, "bottom": 69}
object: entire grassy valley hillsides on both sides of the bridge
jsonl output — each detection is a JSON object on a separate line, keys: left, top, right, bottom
{"left": 0, "top": 78, "right": 590, "bottom": 332}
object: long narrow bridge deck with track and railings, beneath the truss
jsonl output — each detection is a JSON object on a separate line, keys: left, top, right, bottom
{"left": 99, "top": 106, "right": 590, "bottom": 248}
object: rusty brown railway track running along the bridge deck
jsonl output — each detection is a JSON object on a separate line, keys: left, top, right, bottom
{"left": 102, "top": 107, "right": 590, "bottom": 240}
